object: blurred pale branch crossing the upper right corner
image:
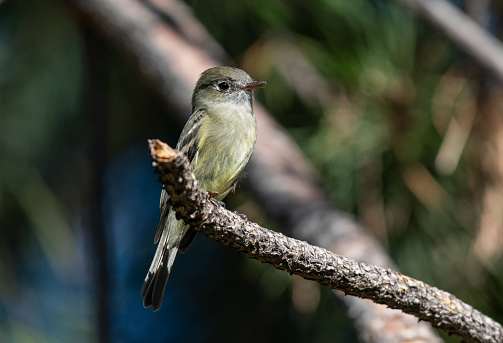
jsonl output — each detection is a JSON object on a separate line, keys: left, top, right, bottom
{"left": 399, "top": 0, "right": 503, "bottom": 81}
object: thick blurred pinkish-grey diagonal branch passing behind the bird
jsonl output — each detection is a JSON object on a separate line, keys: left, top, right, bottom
{"left": 66, "top": 0, "right": 503, "bottom": 343}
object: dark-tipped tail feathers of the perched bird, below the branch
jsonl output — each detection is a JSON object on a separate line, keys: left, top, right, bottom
{"left": 141, "top": 222, "right": 180, "bottom": 311}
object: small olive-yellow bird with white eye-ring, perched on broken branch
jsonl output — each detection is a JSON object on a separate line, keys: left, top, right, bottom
{"left": 141, "top": 66, "right": 265, "bottom": 312}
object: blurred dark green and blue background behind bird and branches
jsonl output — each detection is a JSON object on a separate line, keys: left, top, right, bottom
{"left": 0, "top": 0, "right": 503, "bottom": 343}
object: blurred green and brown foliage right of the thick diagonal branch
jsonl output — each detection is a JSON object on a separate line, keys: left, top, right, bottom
{"left": 188, "top": 0, "right": 503, "bottom": 338}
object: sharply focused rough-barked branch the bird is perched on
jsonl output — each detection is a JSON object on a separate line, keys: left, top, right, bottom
{"left": 149, "top": 140, "right": 503, "bottom": 343}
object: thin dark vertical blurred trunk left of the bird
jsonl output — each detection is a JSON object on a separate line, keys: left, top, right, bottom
{"left": 82, "top": 27, "right": 110, "bottom": 343}
